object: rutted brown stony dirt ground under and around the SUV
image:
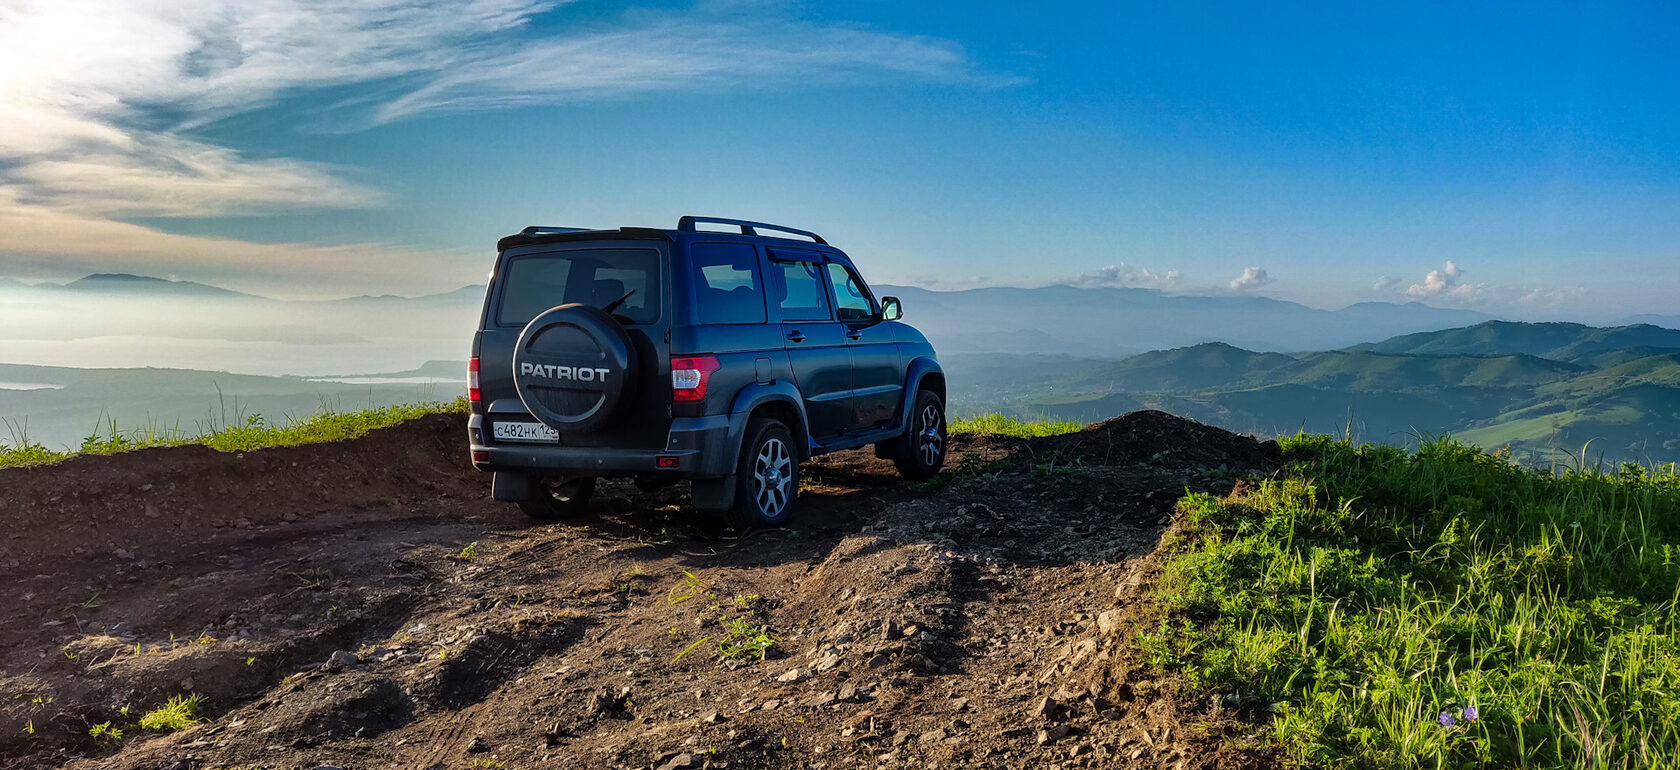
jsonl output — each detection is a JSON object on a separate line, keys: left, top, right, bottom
{"left": 0, "top": 412, "right": 1275, "bottom": 770}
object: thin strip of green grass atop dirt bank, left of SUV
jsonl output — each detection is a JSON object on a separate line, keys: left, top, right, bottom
{"left": 0, "top": 398, "right": 467, "bottom": 467}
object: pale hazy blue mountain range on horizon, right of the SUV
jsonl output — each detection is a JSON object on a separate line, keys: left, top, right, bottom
{"left": 875, "top": 286, "right": 1490, "bottom": 356}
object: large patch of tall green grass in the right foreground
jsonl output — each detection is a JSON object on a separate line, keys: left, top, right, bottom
{"left": 1139, "top": 435, "right": 1680, "bottom": 768}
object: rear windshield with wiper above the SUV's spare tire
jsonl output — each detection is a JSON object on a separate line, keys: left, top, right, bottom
{"left": 496, "top": 249, "right": 662, "bottom": 326}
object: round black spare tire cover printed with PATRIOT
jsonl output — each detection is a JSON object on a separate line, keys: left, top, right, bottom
{"left": 514, "top": 304, "right": 635, "bottom": 430}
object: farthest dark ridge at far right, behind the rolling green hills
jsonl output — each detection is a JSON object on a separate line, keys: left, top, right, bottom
{"left": 1351, "top": 321, "right": 1680, "bottom": 361}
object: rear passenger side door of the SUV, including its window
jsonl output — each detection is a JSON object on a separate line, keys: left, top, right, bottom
{"left": 769, "top": 249, "right": 857, "bottom": 444}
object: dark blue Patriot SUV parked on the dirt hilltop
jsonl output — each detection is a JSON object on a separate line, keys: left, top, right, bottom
{"left": 467, "top": 217, "right": 946, "bottom": 531}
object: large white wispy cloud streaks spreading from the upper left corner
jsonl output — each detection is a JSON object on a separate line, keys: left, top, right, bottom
{"left": 0, "top": 0, "right": 1011, "bottom": 289}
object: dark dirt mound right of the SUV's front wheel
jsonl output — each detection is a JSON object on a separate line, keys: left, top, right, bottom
{"left": 1026, "top": 410, "right": 1278, "bottom": 471}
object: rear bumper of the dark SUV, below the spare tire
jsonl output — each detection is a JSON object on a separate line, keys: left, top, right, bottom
{"left": 467, "top": 414, "right": 739, "bottom": 479}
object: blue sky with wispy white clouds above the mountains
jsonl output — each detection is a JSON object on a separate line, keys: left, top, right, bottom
{"left": 0, "top": 0, "right": 1680, "bottom": 321}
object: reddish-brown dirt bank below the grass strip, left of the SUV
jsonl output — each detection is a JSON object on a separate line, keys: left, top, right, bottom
{"left": 0, "top": 415, "right": 484, "bottom": 575}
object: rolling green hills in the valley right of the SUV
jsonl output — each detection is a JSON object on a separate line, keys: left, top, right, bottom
{"left": 953, "top": 321, "right": 1680, "bottom": 464}
